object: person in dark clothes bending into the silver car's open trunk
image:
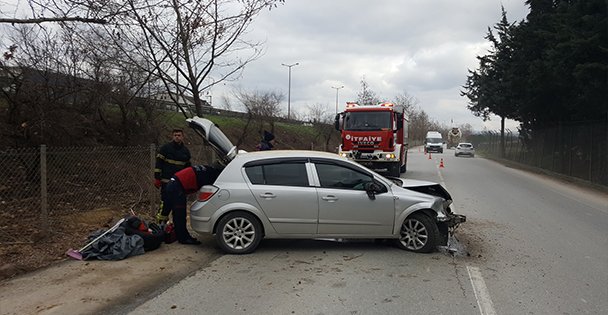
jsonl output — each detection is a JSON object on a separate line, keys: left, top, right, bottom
{"left": 165, "top": 165, "right": 221, "bottom": 245}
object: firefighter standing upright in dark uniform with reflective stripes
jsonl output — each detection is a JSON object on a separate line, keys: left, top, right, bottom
{"left": 154, "top": 128, "right": 191, "bottom": 224}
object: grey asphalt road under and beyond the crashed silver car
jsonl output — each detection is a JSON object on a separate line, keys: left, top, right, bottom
{"left": 126, "top": 148, "right": 608, "bottom": 314}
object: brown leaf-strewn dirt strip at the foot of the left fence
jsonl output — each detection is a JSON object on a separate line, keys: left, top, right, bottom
{"left": 0, "top": 208, "right": 128, "bottom": 280}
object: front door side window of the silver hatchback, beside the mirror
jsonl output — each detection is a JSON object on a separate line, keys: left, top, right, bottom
{"left": 315, "top": 163, "right": 373, "bottom": 190}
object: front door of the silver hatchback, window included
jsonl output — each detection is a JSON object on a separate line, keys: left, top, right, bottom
{"left": 314, "top": 160, "right": 395, "bottom": 236}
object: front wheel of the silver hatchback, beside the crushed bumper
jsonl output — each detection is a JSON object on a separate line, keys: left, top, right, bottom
{"left": 396, "top": 212, "right": 440, "bottom": 253}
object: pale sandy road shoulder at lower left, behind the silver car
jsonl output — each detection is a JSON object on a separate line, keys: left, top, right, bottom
{"left": 0, "top": 239, "right": 220, "bottom": 315}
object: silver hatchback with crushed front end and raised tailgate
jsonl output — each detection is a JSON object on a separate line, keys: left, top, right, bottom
{"left": 188, "top": 117, "right": 466, "bottom": 254}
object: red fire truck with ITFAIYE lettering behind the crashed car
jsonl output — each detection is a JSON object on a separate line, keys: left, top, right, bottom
{"left": 335, "top": 102, "right": 408, "bottom": 177}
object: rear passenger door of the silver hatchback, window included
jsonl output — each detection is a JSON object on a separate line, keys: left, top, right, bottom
{"left": 245, "top": 159, "right": 319, "bottom": 235}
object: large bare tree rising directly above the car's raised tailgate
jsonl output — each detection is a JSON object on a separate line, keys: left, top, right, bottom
{"left": 72, "top": 0, "right": 284, "bottom": 116}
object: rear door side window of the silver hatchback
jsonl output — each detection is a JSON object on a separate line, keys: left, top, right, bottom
{"left": 245, "top": 163, "right": 309, "bottom": 186}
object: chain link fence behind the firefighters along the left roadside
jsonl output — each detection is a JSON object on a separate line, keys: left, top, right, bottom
{"left": 0, "top": 145, "right": 213, "bottom": 243}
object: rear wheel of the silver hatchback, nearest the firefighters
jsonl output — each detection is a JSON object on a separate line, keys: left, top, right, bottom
{"left": 215, "top": 211, "right": 262, "bottom": 255}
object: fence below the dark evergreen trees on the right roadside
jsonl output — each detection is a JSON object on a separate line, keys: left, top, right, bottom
{"left": 471, "top": 121, "right": 608, "bottom": 186}
